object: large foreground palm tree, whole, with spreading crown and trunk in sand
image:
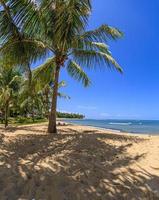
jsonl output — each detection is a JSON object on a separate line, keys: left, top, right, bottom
{"left": 0, "top": 0, "right": 122, "bottom": 133}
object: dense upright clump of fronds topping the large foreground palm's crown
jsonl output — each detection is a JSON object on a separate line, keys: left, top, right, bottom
{"left": 42, "top": 0, "right": 91, "bottom": 50}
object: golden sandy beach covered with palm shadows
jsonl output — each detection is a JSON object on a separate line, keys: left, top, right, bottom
{"left": 0, "top": 124, "right": 159, "bottom": 200}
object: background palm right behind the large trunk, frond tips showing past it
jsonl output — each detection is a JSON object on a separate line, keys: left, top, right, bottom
{"left": 19, "top": 66, "right": 70, "bottom": 121}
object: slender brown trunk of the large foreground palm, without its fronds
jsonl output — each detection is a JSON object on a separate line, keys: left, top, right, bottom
{"left": 48, "top": 65, "right": 60, "bottom": 134}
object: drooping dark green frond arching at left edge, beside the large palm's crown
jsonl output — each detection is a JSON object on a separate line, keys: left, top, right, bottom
{"left": 0, "top": 38, "right": 49, "bottom": 65}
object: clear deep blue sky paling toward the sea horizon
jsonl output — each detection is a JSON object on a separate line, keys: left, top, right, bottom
{"left": 39, "top": 0, "right": 159, "bottom": 119}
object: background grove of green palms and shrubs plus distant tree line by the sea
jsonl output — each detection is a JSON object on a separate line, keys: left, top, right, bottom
{"left": 0, "top": 63, "right": 84, "bottom": 127}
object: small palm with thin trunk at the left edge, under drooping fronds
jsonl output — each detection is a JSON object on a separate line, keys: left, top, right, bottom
{"left": 0, "top": 62, "right": 22, "bottom": 128}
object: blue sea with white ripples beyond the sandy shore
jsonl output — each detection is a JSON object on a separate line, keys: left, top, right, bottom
{"left": 63, "top": 119, "right": 159, "bottom": 135}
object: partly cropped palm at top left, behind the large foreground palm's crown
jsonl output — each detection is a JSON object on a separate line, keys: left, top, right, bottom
{"left": 0, "top": 0, "right": 47, "bottom": 84}
